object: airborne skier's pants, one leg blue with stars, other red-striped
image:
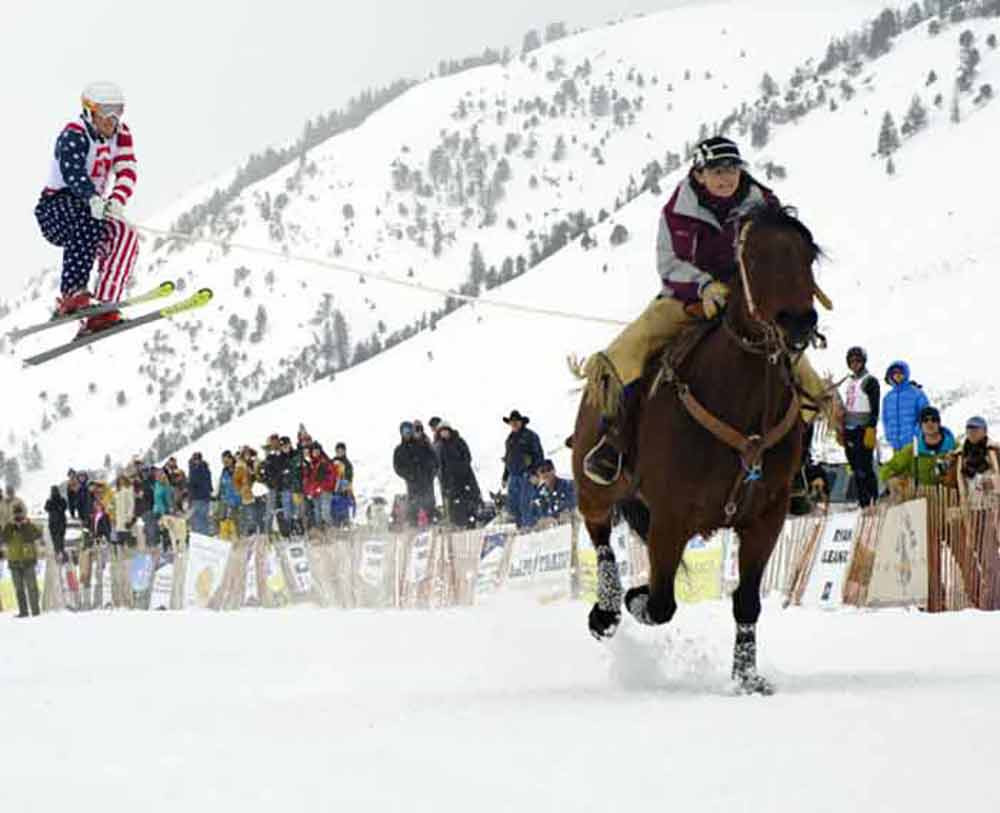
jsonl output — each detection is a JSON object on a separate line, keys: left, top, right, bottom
{"left": 35, "top": 191, "right": 139, "bottom": 302}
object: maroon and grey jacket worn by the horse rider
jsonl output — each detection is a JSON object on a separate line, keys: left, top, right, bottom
{"left": 656, "top": 175, "right": 778, "bottom": 305}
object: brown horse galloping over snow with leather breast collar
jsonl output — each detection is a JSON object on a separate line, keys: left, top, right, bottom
{"left": 572, "top": 206, "right": 829, "bottom": 694}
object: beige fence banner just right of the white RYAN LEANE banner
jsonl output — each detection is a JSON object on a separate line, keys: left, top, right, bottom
{"left": 868, "top": 499, "right": 927, "bottom": 607}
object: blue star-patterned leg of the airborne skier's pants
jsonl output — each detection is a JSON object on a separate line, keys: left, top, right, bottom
{"left": 35, "top": 191, "right": 107, "bottom": 295}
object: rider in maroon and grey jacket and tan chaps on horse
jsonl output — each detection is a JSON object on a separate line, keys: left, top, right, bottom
{"left": 583, "top": 136, "right": 827, "bottom": 486}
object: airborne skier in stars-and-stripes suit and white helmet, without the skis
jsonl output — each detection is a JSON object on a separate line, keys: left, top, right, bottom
{"left": 35, "top": 82, "right": 139, "bottom": 335}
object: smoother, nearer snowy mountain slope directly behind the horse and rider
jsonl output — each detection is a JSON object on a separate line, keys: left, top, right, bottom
{"left": 148, "top": 4, "right": 1000, "bottom": 502}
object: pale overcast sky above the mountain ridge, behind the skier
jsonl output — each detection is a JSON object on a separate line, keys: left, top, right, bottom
{"left": 0, "top": 0, "right": 681, "bottom": 296}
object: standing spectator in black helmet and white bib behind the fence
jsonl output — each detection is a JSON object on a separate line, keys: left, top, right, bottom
{"left": 843, "top": 347, "right": 881, "bottom": 508}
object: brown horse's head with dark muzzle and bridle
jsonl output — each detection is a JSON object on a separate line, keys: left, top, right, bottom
{"left": 734, "top": 206, "right": 826, "bottom": 350}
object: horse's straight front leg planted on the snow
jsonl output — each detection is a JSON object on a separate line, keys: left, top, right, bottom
{"left": 733, "top": 495, "right": 788, "bottom": 695}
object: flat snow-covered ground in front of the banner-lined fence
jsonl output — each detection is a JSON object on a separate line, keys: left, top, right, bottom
{"left": 0, "top": 596, "right": 1000, "bottom": 813}
